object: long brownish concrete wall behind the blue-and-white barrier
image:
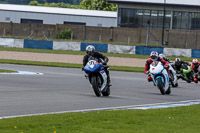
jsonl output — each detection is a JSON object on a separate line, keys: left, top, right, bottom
{"left": 0, "top": 23, "right": 200, "bottom": 49}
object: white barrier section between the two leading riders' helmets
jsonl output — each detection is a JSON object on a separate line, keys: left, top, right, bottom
{"left": 108, "top": 44, "right": 135, "bottom": 54}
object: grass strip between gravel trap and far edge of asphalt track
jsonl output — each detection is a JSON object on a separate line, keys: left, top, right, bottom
{"left": 0, "top": 59, "right": 144, "bottom": 72}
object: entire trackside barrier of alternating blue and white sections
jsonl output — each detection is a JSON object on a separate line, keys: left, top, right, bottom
{"left": 0, "top": 38, "right": 200, "bottom": 58}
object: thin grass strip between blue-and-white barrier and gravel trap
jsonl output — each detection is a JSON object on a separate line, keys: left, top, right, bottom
{"left": 0, "top": 47, "right": 193, "bottom": 61}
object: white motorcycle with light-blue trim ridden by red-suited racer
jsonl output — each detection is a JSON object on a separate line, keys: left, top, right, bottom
{"left": 150, "top": 61, "right": 171, "bottom": 95}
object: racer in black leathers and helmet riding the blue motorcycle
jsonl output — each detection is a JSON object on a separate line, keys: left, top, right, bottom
{"left": 82, "top": 45, "right": 111, "bottom": 86}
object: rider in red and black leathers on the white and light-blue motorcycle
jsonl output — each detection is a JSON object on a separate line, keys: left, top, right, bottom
{"left": 144, "top": 51, "right": 169, "bottom": 82}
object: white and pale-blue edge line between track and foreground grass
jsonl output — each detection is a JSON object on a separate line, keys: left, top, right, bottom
{"left": 0, "top": 99, "right": 200, "bottom": 119}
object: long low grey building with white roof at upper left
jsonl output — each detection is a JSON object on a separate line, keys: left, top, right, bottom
{"left": 0, "top": 4, "right": 117, "bottom": 27}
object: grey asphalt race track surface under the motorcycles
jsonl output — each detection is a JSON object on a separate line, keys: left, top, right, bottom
{"left": 0, "top": 64, "right": 200, "bottom": 117}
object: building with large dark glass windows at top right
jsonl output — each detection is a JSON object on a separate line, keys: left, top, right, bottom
{"left": 108, "top": 0, "right": 200, "bottom": 30}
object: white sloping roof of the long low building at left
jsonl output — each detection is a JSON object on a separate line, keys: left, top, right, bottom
{"left": 0, "top": 4, "right": 117, "bottom": 18}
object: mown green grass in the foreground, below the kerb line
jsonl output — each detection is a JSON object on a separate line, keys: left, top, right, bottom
{"left": 0, "top": 105, "right": 200, "bottom": 133}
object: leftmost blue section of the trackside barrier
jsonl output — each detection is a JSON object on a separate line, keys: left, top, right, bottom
{"left": 24, "top": 39, "right": 53, "bottom": 49}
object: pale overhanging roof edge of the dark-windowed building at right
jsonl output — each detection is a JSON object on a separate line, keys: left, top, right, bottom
{"left": 108, "top": 0, "right": 200, "bottom": 7}
